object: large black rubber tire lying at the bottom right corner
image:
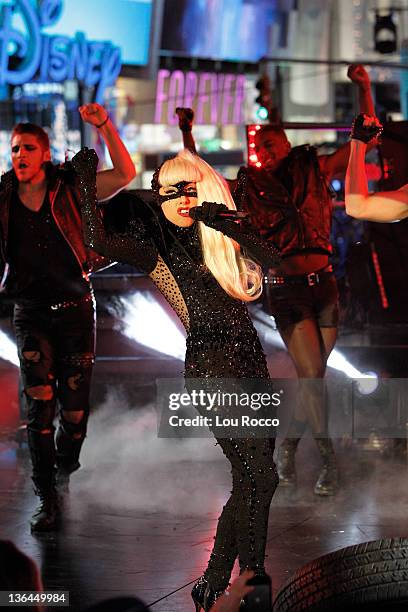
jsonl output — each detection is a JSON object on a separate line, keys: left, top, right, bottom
{"left": 273, "top": 538, "right": 408, "bottom": 612}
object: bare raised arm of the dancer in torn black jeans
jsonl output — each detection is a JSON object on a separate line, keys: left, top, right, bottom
{"left": 79, "top": 104, "right": 136, "bottom": 200}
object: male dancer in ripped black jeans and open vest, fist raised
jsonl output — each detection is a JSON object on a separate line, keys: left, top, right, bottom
{"left": 0, "top": 104, "right": 135, "bottom": 531}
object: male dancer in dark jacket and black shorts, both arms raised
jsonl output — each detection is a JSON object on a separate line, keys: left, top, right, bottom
{"left": 178, "top": 66, "right": 374, "bottom": 495}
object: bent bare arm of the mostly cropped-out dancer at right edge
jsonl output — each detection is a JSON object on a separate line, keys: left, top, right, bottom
{"left": 346, "top": 140, "right": 408, "bottom": 223}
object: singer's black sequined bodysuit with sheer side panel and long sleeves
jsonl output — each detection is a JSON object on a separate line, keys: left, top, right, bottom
{"left": 78, "top": 149, "right": 278, "bottom": 591}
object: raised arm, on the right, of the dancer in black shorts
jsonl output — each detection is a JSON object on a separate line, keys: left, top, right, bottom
{"left": 319, "top": 64, "right": 375, "bottom": 180}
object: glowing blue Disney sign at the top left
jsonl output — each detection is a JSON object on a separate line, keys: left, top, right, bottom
{"left": 0, "top": 0, "right": 121, "bottom": 102}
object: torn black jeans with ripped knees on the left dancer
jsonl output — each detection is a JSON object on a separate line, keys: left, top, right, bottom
{"left": 14, "top": 294, "right": 95, "bottom": 489}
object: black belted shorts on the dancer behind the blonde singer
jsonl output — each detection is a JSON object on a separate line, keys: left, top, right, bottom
{"left": 264, "top": 272, "right": 339, "bottom": 329}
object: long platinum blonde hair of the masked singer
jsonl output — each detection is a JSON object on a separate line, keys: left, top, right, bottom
{"left": 158, "top": 149, "right": 262, "bottom": 302}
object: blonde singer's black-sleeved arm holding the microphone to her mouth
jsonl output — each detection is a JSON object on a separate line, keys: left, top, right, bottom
{"left": 190, "top": 202, "right": 281, "bottom": 267}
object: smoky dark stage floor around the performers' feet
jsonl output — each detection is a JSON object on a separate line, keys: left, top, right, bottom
{"left": 0, "top": 436, "right": 408, "bottom": 612}
